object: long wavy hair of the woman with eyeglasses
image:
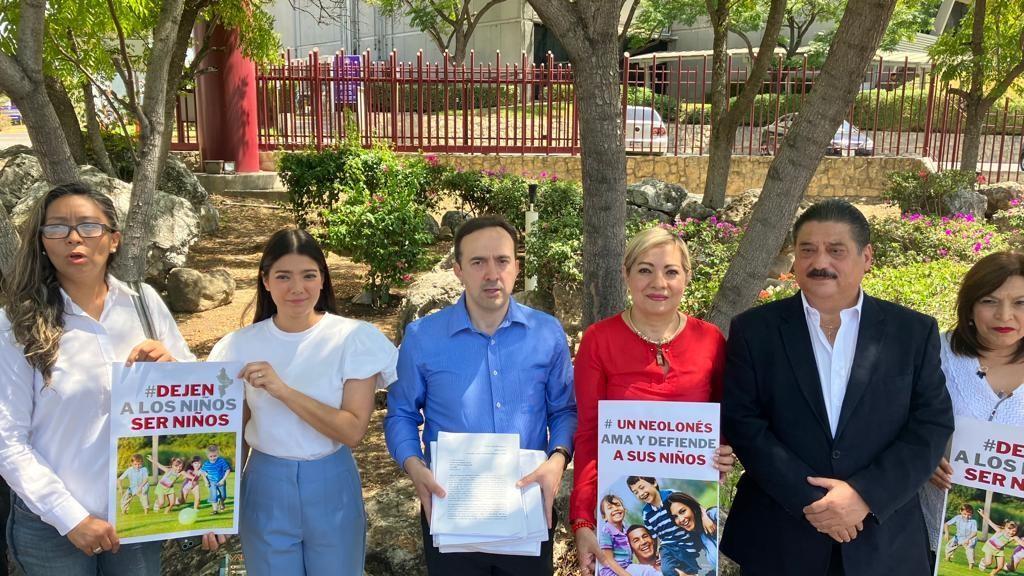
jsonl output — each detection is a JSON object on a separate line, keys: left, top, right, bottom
{"left": 3, "top": 182, "right": 118, "bottom": 386}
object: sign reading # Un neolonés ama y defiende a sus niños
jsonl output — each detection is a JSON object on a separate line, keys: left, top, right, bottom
{"left": 597, "top": 401, "right": 720, "bottom": 576}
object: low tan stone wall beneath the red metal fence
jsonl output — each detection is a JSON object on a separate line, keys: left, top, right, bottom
{"left": 260, "top": 147, "right": 934, "bottom": 198}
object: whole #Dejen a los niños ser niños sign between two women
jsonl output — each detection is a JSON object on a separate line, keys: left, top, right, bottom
{"left": 108, "top": 362, "right": 244, "bottom": 543}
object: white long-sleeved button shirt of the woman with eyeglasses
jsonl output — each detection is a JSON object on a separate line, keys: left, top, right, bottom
{"left": 0, "top": 276, "right": 196, "bottom": 535}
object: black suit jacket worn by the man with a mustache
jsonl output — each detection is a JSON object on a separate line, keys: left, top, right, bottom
{"left": 722, "top": 294, "right": 953, "bottom": 576}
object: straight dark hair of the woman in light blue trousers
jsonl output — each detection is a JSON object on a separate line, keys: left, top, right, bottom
{"left": 253, "top": 229, "right": 338, "bottom": 324}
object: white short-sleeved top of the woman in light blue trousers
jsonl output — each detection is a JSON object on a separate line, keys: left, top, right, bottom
{"left": 208, "top": 314, "right": 398, "bottom": 460}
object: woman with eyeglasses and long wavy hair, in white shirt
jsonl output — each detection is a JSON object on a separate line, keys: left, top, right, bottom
{"left": 0, "top": 183, "right": 195, "bottom": 576}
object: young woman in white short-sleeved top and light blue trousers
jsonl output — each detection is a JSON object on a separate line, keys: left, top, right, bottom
{"left": 210, "top": 230, "right": 397, "bottom": 576}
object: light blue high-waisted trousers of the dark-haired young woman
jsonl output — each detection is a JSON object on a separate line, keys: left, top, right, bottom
{"left": 239, "top": 446, "right": 367, "bottom": 576}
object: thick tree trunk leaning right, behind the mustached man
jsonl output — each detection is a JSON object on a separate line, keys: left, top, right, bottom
{"left": 709, "top": 0, "right": 897, "bottom": 333}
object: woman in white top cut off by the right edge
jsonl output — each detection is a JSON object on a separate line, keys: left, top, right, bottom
{"left": 921, "top": 252, "right": 1024, "bottom": 553}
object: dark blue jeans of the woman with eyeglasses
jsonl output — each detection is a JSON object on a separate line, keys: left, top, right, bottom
{"left": 7, "top": 496, "right": 164, "bottom": 576}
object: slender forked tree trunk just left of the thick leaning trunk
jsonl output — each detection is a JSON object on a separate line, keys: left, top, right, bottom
{"left": 701, "top": 0, "right": 785, "bottom": 210}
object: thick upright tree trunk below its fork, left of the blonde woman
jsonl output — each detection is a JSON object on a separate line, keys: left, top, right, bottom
{"left": 573, "top": 48, "right": 626, "bottom": 326}
